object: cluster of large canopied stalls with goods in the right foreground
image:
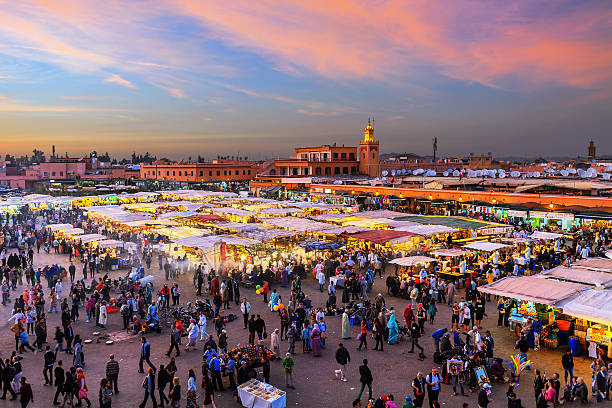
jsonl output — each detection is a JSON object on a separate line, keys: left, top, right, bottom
{"left": 478, "top": 258, "right": 612, "bottom": 357}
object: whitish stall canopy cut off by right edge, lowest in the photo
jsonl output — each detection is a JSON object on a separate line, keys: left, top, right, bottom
{"left": 563, "top": 289, "right": 612, "bottom": 326}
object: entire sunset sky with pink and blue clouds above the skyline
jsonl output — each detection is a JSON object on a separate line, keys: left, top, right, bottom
{"left": 0, "top": 0, "right": 612, "bottom": 159}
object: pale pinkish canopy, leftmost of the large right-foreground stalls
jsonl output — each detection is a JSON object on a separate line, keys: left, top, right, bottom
{"left": 478, "top": 276, "right": 589, "bottom": 306}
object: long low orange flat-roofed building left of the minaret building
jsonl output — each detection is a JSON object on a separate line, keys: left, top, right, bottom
{"left": 140, "top": 160, "right": 259, "bottom": 183}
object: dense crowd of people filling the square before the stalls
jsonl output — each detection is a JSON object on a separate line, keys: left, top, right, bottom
{"left": 0, "top": 204, "right": 612, "bottom": 408}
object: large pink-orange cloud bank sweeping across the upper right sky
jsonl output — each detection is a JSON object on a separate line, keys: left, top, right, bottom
{"left": 176, "top": 0, "right": 612, "bottom": 86}
